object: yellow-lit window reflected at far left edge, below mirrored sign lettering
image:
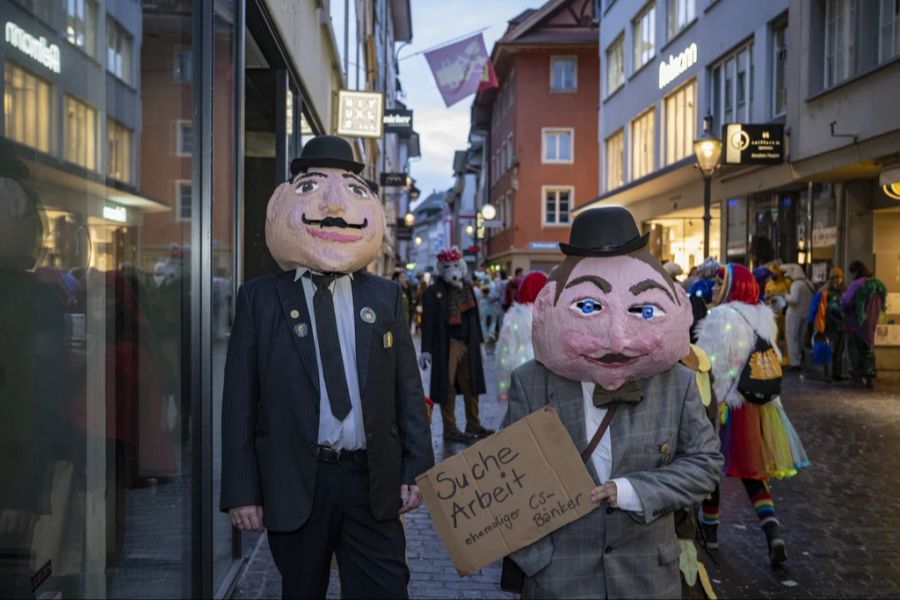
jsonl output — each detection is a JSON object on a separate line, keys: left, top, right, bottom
{"left": 3, "top": 62, "right": 51, "bottom": 152}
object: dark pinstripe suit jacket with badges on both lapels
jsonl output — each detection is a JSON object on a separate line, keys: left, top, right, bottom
{"left": 220, "top": 271, "right": 434, "bottom": 531}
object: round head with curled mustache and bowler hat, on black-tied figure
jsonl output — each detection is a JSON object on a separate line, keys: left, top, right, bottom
{"left": 266, "top": 136, "right": 385, "bottom": 273}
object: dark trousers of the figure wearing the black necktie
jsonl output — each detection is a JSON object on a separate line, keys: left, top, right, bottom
{"left": 268, "top": 461, "right": 409, "bottom": 599}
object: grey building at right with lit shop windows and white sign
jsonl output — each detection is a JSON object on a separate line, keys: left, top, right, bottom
{"left": 579, "top": 0, "right": 900, "bottom": 366}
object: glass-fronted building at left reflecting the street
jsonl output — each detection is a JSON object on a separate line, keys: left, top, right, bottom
{"left": 0, "top": 0, "right": 409, "bottom": 598}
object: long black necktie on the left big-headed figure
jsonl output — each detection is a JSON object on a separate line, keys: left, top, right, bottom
{"left": 307, "top": 271, "right": 351, "bottom": 421}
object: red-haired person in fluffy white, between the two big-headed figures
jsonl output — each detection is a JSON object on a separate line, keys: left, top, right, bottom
{"left": 494, "top": 271, "right": 547, "bottom": 400}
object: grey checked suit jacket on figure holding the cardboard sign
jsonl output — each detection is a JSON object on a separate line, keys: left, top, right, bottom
{"left": 504, "top": 361, "right": 723, "bottom": 598}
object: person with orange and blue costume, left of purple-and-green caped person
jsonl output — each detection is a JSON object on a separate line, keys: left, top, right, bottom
{"left": 808, "top": 267, "right": 846, "bottom": 382}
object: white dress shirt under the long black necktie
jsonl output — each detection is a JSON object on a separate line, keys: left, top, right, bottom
{"left": 294, "top": 267, "right": 366, "bottom": 450}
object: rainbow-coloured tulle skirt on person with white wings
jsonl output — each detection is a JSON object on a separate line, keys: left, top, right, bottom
{"left": 719, "top": 398, "right": 810, "bottom": 480}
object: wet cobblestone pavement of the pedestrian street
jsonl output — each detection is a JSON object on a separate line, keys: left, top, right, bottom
{"left": 234, "top": 340, "right": 900, "bottom": 600}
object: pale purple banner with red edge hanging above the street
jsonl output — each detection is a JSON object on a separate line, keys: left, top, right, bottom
{"left": 425, "top": 33, "right": 497, "bottom": 107}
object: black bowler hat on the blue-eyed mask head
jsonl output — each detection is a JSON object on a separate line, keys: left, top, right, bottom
{"left": 559, "top": 206, "right": 650, "bottom": 256}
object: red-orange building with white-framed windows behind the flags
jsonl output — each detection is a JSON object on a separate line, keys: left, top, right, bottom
{"left": 472, "top": 0, "right": 600, "bottom": 271}
